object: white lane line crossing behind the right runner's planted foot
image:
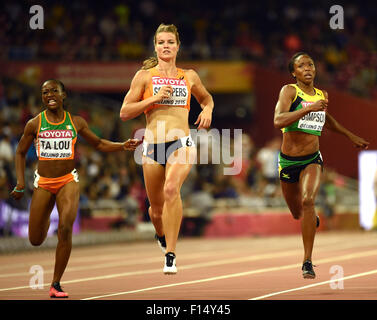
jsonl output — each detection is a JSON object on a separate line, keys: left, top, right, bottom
{"left": 82, "top": 250, "right": 377, "bottom": 300}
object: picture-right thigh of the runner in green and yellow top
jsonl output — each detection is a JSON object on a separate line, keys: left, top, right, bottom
{"left": 300, "top": 163, "right": 322, "bottom": 199}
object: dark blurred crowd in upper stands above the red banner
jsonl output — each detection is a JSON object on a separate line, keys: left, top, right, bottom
{"left": 0, "top": 0, "right": 377, "bottom": 98}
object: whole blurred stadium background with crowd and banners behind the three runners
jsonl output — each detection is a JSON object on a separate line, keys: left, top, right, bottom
{"left": 0, "top": 0, "right": 377, "bottom": 252}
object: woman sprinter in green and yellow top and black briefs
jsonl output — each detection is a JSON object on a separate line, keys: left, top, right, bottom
{"left": 274, "top": 52, "right": 369, "bottom": 279}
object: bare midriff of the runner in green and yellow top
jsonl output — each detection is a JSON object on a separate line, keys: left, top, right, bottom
{"left": 281, "top": 131, "right": 319, "bottom": 157}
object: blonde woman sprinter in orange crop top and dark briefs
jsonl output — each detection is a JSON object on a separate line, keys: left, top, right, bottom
{"left": 120, "top": 24, "right": 214, "bottom": 274}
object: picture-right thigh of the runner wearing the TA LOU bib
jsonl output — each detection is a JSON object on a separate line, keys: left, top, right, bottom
{"left": 56, "top": 181, "right": 80, "bottom": 225}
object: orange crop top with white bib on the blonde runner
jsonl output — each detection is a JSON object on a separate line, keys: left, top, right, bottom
{"left": 143, "top": 67, "right": 191, "bottom": 113}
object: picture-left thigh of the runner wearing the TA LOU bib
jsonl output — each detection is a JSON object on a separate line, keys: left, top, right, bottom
{"left": 29, "top": 187, "right": 55, "bottom": 234}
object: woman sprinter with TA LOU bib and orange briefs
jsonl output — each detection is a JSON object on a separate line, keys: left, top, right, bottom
{"left": 11, "top": 79, "right": 141, "bottom": 298}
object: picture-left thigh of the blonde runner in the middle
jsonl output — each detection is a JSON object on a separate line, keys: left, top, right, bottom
{"left": 143, "top": 162, "right": 165, "bottom": 207}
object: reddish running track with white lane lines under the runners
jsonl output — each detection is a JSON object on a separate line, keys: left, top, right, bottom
{"left": 0, "top": 231, "right": 377, "bottom": 300}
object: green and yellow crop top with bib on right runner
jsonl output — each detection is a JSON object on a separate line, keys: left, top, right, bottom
{"left": 282, "top": 84, "right": 326, "bottom": 136}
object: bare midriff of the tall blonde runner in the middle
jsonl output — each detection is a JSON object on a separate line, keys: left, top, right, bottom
{"left": 144, "top": 106, "right": 190, "bottom": 143}
